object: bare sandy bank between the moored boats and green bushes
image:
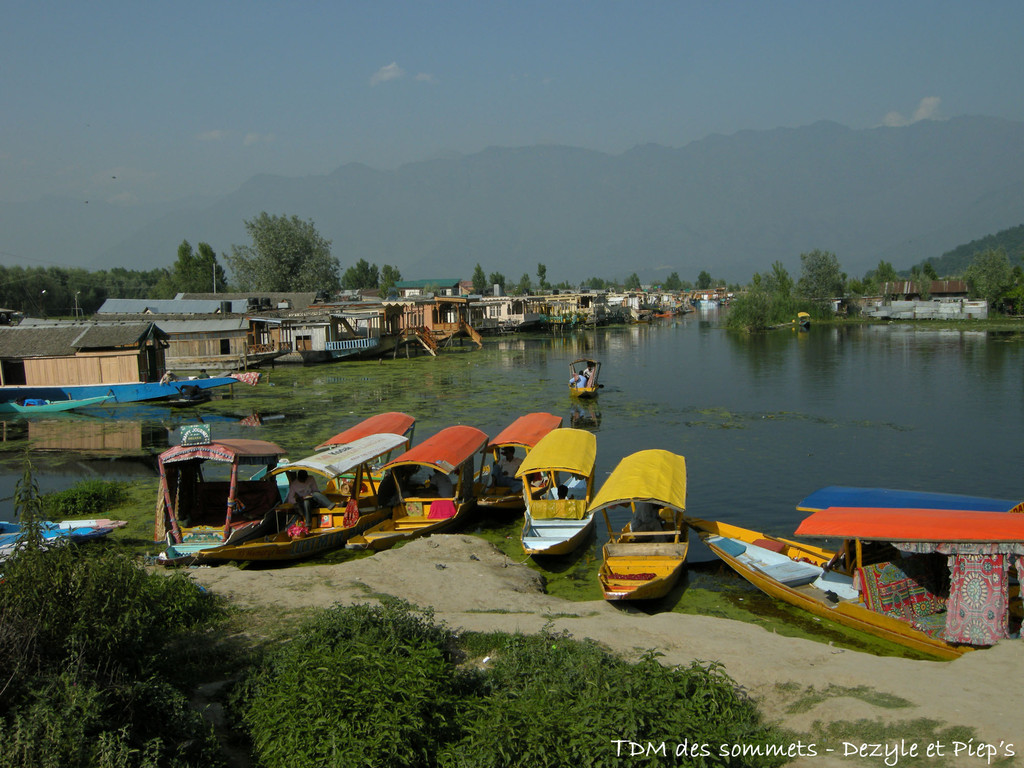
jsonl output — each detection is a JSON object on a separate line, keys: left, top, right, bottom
{"left": 189, "top": 535, "right": 1024, "bottom": 766}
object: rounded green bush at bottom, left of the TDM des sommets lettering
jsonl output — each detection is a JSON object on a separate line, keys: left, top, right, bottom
{"left": 236, "top": 601, "right": 460, "bottom": 768}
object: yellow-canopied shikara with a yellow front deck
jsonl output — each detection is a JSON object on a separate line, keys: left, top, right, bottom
{"left": 589, "top": 450, "right": 689, "bottom": 600}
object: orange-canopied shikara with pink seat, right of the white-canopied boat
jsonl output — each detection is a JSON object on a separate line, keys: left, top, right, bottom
{"left": 346, "top": 426, "right": 487, "bottom": 550}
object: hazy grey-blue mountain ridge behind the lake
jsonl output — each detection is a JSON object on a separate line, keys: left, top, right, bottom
{"left": 0, "top": 117, "right": 1024, "bottom": 282}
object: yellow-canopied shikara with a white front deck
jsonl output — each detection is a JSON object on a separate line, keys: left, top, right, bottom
{"left": 516, "top": 427, "right": 597, "bottom": 556}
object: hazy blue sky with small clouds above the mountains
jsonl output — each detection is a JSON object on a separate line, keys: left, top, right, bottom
{"left": 0, "top": 0, "right": 1024, "bottom": 203}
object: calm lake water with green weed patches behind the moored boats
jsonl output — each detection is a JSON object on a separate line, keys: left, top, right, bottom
{"left": 0, "top": 312, "right": 1024, "bottom": 535}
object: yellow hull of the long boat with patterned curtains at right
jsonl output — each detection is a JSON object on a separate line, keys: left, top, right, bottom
{"left": 687, "top": 518, "right": 972, "bottom": 658}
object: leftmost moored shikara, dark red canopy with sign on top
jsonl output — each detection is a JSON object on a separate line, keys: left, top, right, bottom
{"left": 154, "top": 436, "right": 285, "bottom": 564}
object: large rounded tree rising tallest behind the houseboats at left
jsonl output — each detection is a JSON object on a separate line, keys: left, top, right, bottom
{"left": 225, "top": 211, "right": 341, "bottom": 292}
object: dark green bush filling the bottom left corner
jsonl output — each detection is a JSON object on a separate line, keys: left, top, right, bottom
{"left": 0, "top": 544, "right": 222, "bottom": 768}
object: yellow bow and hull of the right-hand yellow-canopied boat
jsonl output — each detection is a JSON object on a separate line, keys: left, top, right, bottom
{"left": 598, "top": 541, "right": 689, "bottom": 601}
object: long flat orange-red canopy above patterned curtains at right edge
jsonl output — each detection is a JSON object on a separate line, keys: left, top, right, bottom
{"left": 797, "top": 507, "right": 1024, "bottom": 543}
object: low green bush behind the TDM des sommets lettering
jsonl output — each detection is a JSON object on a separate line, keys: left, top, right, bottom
{"left": 440, "top": 634, "right": 784, "bottom": 768}
